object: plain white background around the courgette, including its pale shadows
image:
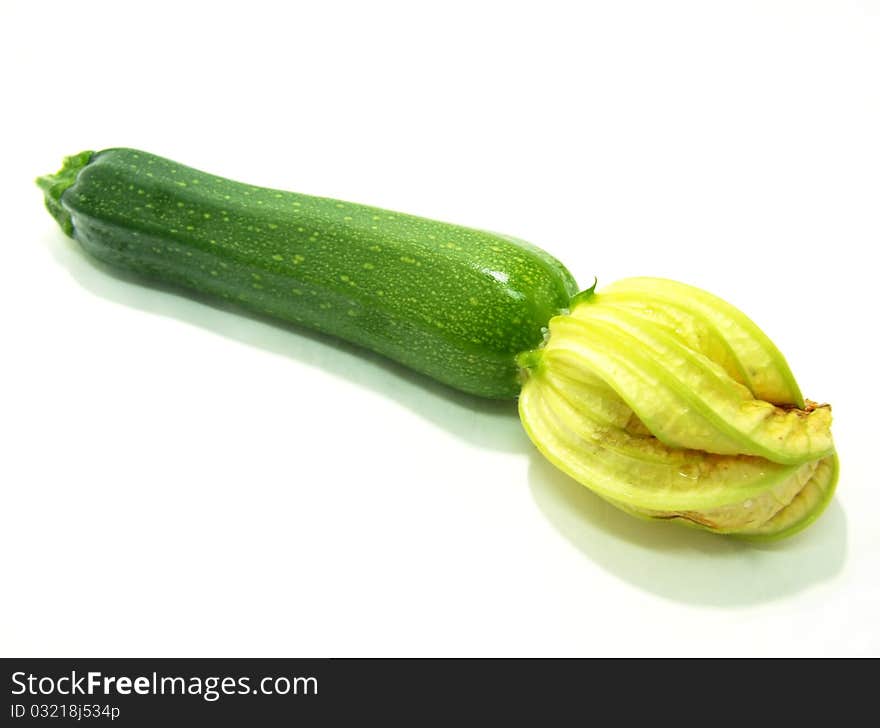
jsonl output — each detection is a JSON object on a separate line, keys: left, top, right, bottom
{"left": 0, "top": 0, "right": 880, "bottom": 656}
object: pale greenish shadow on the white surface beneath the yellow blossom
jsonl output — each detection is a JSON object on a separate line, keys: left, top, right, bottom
{"left": 529, "top": 452, "right": 847, "bottom": 607}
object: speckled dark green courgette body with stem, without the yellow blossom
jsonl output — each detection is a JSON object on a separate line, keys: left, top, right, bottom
{"left": 39, "top": 149, "right": 576, "bottom": 398}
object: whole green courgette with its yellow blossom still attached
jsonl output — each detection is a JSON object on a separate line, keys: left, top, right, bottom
{"left": 38, "top": 149, "right": 838, "bottom": 539}
